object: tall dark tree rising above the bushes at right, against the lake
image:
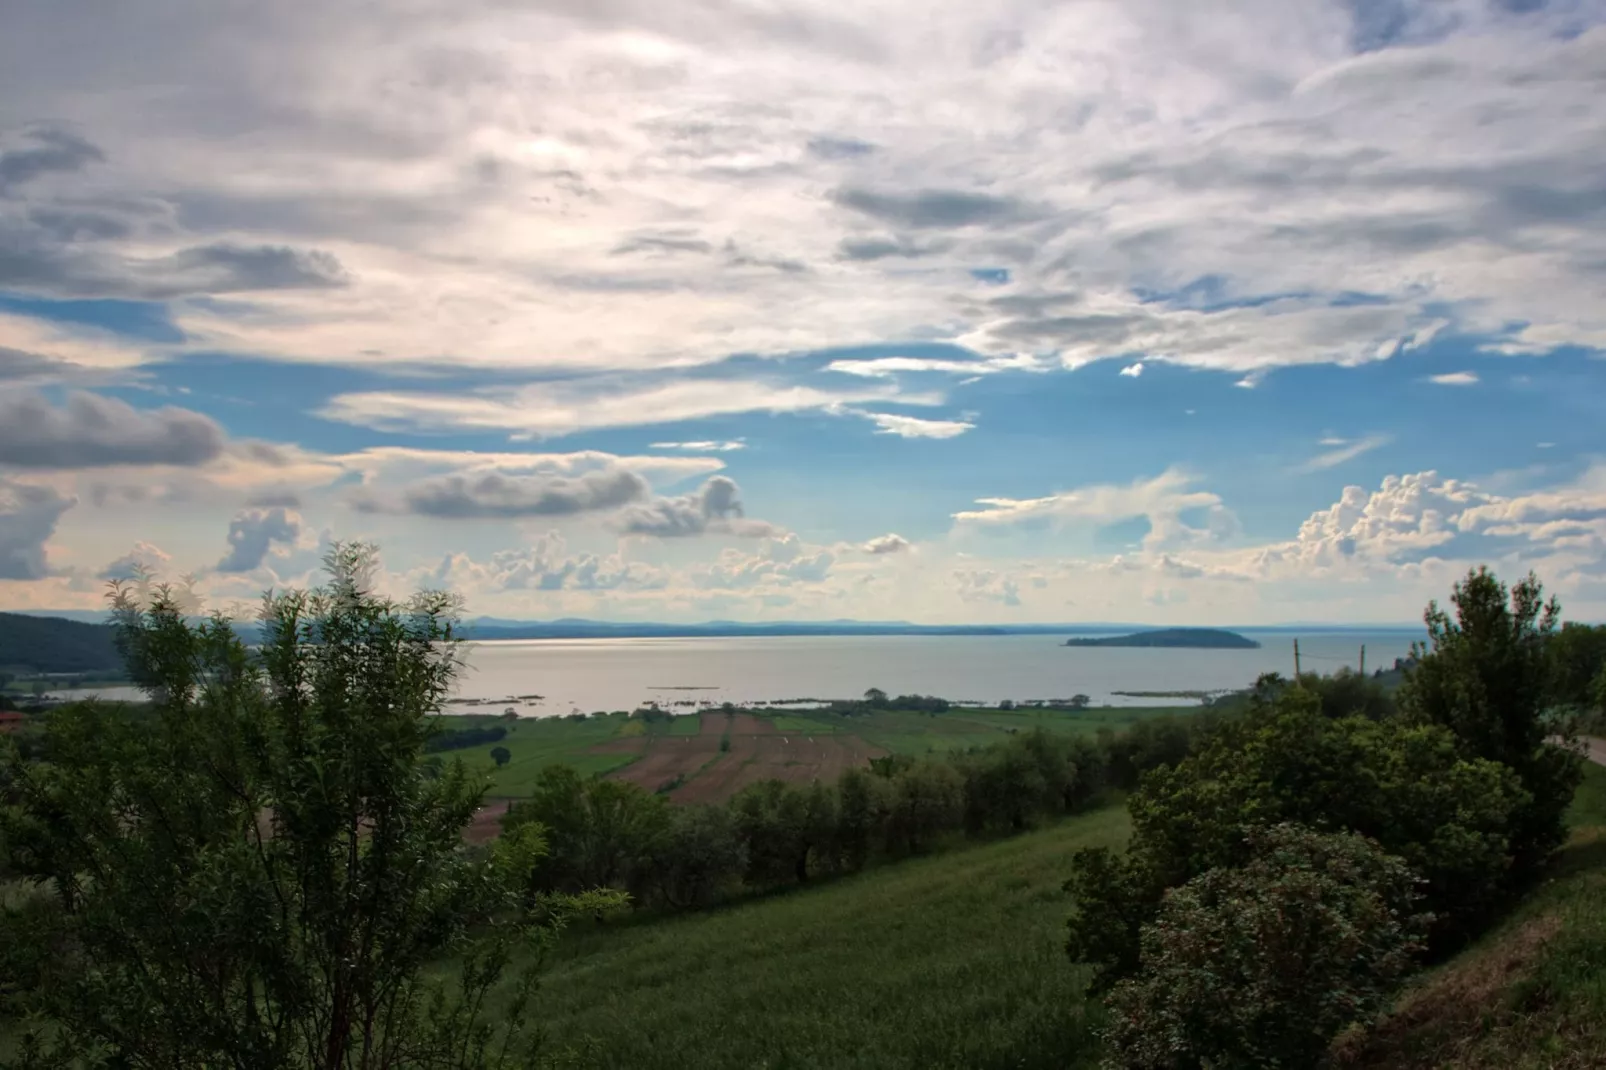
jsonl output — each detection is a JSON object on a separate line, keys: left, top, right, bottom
{"left": 1399, "top": 569, "right": 1582, "bottom": 880}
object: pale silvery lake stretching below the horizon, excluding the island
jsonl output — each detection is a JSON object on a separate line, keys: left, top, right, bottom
{"left": 46, "top": 628, "right": 1423, "bottom": 717}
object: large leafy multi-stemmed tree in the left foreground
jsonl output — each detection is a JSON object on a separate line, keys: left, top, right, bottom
{"left": 0, "top": 545, "right": 619, "bottom": 1070}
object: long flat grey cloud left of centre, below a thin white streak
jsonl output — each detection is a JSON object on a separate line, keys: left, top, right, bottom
{"left": 355, "top": 469, "right": 650, "bottom": 519}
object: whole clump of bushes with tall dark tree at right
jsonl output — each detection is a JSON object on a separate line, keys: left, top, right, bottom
{"left": 1066, "top": 570, "right": 1601, "bottom": 1070}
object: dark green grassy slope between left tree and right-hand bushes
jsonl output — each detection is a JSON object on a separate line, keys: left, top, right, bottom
{"left": 526, "top": 807, "right": 1127, "bottom": 1070}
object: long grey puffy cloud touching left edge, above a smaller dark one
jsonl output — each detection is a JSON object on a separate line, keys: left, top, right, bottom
{"left": 0, "top": 385, "right": 225, "bottom": 469}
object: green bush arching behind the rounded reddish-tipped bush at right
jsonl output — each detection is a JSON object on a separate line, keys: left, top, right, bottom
{"left": 1066, "top": 689, "right": 1527, "bottom": 985}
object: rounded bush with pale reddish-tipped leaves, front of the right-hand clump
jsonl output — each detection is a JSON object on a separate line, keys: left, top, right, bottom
{"left": 1105, "top": 824, "right": 1428, "bottom": 1070}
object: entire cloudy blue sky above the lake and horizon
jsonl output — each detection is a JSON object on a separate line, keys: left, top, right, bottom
{"left": 0, "top": 0, "right": 1606, "bottom": 625}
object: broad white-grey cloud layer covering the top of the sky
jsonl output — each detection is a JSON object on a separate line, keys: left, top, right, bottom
{"left": 0, "top": 0, "right": 1606, "bottom": 390}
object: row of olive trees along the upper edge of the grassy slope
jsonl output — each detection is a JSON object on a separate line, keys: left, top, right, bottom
{"left": 503, "top": 712, "right": 1221, "bottom": 909}
